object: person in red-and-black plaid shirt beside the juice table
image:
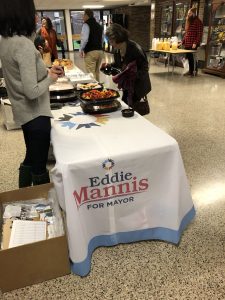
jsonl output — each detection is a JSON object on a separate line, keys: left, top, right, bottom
{"left": 182, "top": 7, "right": 203, "bottom": 76}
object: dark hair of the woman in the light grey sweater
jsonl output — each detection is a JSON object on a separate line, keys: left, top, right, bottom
{"left": 0, "top": 0, "right": 36, "bottom": 37}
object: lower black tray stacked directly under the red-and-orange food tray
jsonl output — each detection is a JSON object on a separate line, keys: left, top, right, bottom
{"left": 81, "top": 100, "right": 121, "bottom": 114}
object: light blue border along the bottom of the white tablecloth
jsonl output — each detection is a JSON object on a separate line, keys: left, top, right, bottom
{"left": 71, "top": 206, "right": 195, "bottom": 276}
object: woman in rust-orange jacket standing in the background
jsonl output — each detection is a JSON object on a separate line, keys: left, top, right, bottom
{"left": 37, "top": 17, "right": 58, "bottom": 62}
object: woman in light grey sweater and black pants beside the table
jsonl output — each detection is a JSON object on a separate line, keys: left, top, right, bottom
{"left": 0, "top": 0, "right": 63, "bottom": 187}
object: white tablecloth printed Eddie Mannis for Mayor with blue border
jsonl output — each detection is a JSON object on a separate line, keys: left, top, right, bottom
{"left": 52, "top": 106, "right": 195, "bottom": 276}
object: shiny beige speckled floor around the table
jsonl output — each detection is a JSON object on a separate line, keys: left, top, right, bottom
{"left": 0, "top": 54, "right": 225, "bottom": 300}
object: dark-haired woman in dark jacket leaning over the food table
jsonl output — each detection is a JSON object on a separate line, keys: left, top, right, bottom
{"left": 106, "top": 24, "right": 151, "bottom": 105}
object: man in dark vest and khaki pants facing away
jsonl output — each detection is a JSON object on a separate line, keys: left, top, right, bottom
{"left": 80, "top": 9, "right": 103, "bottom": 81}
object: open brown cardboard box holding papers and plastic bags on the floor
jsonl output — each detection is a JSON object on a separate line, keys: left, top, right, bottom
{"left": 0, "top": 184, "right": 70, "bottom": 292}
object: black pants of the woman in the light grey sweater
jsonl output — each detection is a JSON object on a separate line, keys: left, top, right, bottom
{"left": 22, "top": 116, "right": 51, "bottom": 175}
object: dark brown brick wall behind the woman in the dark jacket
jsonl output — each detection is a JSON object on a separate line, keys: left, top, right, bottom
{"left": 112, "top": 6, "right": 150, "bottom": 51}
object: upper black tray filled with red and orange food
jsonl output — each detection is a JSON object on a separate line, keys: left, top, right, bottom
{"left": 80, "top": 89, "right": 120, "bottom": 105}
